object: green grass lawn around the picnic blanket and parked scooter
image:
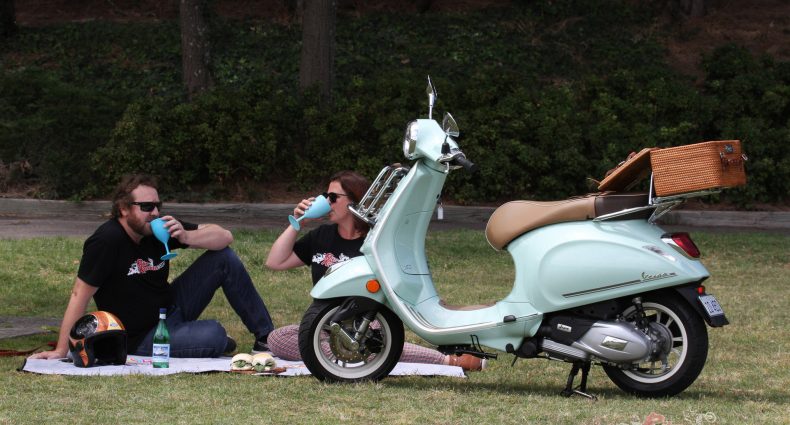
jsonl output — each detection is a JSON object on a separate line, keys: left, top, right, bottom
{"left": 0, "top": 231, "right": 790, "bottom": 424}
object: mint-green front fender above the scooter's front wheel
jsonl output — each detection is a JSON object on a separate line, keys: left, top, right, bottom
{"left": 310, "top": 256, "right": 386, "bottom": 304}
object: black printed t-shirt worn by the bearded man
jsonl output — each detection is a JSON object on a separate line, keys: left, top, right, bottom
{"left": 77, "top": 219, "right": 197, "bottom": 348}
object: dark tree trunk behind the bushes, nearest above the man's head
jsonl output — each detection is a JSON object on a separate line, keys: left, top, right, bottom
{"left": 179, "top": 0, "right": 212, "bottom": 100}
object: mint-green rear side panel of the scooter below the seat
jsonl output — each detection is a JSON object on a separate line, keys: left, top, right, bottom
{"left": 506, "top": 220, "right": 709, "bottom": 313}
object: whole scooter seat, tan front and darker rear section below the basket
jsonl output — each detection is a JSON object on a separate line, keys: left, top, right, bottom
{"left": 486, "top": 192, "right": 652, "bottom": 250}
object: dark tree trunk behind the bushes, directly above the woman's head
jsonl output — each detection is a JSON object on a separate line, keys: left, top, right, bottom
{"left": 299, "top": 0, "right": 337, "bottom": 102}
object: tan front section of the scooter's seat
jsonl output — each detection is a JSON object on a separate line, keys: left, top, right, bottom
{"left": 486, "top": 196, "right": 595, "bottom": 250}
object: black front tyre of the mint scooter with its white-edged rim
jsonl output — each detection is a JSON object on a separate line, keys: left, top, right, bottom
{"left": 299, "top": 298, "right": 404, "bottom": 382}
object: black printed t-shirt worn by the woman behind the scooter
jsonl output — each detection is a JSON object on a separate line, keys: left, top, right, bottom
{"left": 294, "top": 224, "right": 365, "bottom": 285}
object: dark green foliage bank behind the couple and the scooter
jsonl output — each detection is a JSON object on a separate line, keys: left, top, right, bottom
{"left": 0, "top": 0, "right": 790, "bottom": 208}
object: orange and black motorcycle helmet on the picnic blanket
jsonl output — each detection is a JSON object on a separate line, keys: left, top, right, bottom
{"left": 69, "top": 311, "right": 126, "bottom": 367}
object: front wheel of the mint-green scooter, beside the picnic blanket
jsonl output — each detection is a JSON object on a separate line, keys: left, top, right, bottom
{"left": 299, "top": 299, "right": 404, "bottom": 382}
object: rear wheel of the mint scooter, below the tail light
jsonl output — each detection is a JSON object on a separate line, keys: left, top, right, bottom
{"left": 603, "top": 292, "right": 708, "bottom": 397}
